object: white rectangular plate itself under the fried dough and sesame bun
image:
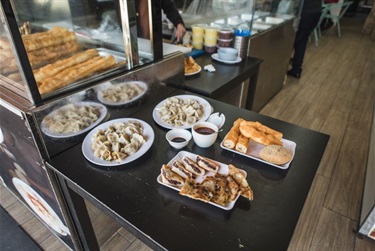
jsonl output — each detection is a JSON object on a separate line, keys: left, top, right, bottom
{"left": 220, "top": 137, "right": 297, "bottom": 169}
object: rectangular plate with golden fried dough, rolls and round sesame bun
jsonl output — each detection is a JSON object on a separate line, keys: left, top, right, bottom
{"left": 220, "top": 118, "right": 296, "bottom": 169}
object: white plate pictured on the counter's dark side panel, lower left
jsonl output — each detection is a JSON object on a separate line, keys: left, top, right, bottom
{"left": 12, "top": 178, "right": 70, "bottom": 236}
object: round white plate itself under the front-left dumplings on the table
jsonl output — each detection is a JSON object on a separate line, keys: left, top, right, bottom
{"left": 82, "top": 118, "right": 155, "bottom": 166}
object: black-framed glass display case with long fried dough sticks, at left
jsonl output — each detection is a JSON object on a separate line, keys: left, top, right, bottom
{"left": 0, "top": 0, "right": 163, "bottom": 104}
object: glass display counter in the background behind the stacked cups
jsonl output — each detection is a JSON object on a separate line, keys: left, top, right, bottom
{"left": 176, "top": 0, "right": 303, "bottom": 34}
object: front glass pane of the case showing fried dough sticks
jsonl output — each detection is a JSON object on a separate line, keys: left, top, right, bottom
{"left": 3, "top": 0, "right": 154, "bottom": 98}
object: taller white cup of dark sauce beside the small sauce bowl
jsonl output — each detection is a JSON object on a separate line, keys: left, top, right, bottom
{"left": 191, "top": 122, "right": 219, "bottom": 148}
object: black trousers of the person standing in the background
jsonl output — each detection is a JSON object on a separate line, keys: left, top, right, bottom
{"left": 292, "top": 11, "right": 321, "bottom": 74}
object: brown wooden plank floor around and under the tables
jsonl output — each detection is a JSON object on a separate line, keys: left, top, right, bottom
{"left": 0, "top": 15, "right": 375, "bottom": 251}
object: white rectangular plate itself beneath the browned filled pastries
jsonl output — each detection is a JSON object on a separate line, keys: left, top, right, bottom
{"left": 157, "top": 151, "right": 247, "bottom": 210}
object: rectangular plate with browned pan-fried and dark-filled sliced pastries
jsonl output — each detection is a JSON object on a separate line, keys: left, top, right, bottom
{"left": 157, "top": 151, "right": 254, "bottom": 210}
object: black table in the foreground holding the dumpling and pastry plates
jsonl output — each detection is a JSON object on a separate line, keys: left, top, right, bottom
{"left": 47, "top": 89, "right": 329, "bottom": 251}
